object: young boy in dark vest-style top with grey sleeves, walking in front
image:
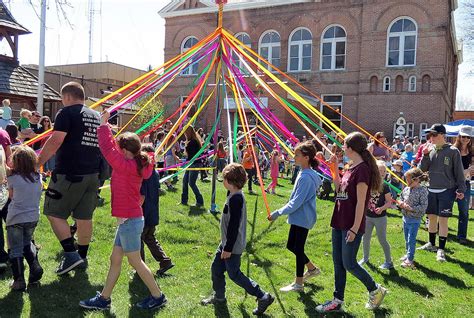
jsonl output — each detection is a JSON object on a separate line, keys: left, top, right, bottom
{"left": 201, "top": 163, "right": 275, "bottom": 315}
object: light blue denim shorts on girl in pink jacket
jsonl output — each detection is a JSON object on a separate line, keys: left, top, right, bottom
{"left": 114, "top": 217, "right": 145, "bottom": 253}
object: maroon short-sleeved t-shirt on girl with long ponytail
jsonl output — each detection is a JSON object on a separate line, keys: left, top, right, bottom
{"left": 331, "top": 162, "right": 370, "bottom": 233}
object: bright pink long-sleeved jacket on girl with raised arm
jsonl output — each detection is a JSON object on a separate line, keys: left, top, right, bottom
{"left": 97, "top": 125, "right": 153, "bottom": 218}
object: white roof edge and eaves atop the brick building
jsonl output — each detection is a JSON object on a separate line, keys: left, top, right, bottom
{"left": 158, "top": 0, "right": 314, "bottom": 18}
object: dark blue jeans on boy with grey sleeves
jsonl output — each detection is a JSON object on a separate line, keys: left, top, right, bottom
{"left": 211, "top": 246, "right": 265, "bottom": 298}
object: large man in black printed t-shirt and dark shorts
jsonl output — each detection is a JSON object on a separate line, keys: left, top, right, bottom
{"left": 38, "top": 82, "right": 100, "bottom": 275}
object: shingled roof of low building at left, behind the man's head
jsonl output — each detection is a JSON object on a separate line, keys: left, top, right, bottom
{"left": 0, "top": 61, "right": 61, "bottom": 101}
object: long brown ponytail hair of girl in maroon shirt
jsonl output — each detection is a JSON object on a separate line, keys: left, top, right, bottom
{"left": 345, "top": 132, "right": 382, "bottom": 192}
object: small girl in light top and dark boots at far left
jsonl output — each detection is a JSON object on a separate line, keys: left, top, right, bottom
{"left": 6, "top": 146, "right": 43, "bottom": 291}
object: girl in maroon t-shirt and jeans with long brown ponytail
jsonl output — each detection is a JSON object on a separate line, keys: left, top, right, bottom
{"left": 316, "top": 132, "right": 387, "bottom": 313}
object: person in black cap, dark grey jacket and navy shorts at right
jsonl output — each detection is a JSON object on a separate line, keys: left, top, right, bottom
{"left": 419, "top": 124, "right": 466, "bottom": 262}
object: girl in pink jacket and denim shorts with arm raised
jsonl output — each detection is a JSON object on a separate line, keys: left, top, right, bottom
{"left": 79, "top": 112, "right": 167, "bottom": 310}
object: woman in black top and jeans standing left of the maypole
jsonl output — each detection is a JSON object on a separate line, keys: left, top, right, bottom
{"left": 181, "top": 126, "right": 204, "bottom": 207}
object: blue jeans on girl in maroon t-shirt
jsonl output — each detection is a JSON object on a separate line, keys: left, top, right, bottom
{"left": 332, "top": 229, "right": 377, "bottom": 300}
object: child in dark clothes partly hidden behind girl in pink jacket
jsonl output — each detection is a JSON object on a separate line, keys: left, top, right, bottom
{"left": 140, "top": 145, "right": 174, "bottom": 276}
